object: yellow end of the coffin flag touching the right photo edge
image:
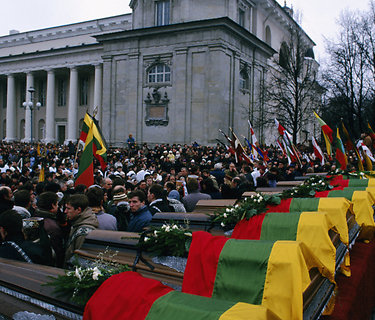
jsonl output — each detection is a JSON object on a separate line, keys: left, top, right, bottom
{"left": 352, "top": 191, "right": 375, "bottom": 240}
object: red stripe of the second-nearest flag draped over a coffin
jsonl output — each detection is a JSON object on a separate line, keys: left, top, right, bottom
{"left": 182, "top": 231, "right": 229, "bottom": 297}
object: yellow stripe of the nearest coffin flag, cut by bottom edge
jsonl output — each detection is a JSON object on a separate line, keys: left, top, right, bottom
{"left": 219, "top": 302, "right": 281, "bottom": 320}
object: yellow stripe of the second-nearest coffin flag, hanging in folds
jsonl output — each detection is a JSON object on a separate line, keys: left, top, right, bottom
{"left": 262, "top": 241, "right": 319, "bottom": 320}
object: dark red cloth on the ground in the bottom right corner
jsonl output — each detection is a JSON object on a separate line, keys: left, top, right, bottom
{"left": 324, "top": 241, "right": 375, "bottom": 320}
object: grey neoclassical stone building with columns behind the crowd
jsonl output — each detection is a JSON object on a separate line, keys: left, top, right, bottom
{"left": 0, "top": 0, "right": 315, "bottom": 146}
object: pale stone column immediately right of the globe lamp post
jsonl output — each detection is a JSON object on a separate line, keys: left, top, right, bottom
{"left": 44, "top": 70, "right": 55, "bottom": 144}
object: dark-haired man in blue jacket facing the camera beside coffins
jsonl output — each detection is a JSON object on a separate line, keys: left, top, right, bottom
{"left": 127, "top": 190, "right": 152, "bottom": 232}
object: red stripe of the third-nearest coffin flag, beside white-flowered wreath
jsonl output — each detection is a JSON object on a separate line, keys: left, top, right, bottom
{"left": 232, "top": 213, "right": 266, "bottom": 240}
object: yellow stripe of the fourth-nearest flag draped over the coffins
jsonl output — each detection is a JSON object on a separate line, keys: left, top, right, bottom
{"left": 318, "top": 198, "right": 352, "bottom": 245}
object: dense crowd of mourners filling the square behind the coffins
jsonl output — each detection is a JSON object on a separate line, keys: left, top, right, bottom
{"left": 0, "top": 141, "right": 352, "bottom": 267}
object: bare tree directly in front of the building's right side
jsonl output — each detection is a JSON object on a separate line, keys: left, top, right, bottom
{"left": 265, "top": 28, "right": 322, "bottom": 143}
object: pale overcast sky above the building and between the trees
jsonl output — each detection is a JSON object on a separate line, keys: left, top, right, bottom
{"left": 0, "top": 0, "right": 369, "bottom": 61}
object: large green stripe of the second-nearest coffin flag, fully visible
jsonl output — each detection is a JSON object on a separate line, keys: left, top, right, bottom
{"left": 212, "top": 239, "right": 274, "bottom": 305}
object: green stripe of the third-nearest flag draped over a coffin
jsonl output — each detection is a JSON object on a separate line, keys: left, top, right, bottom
{"left": 260, "top": 212, "right": 301, "bottom": 241}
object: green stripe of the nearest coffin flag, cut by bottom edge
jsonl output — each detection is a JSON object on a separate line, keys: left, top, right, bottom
{"left": 146, "top": 291, "right": 236, "bottom": 320}
